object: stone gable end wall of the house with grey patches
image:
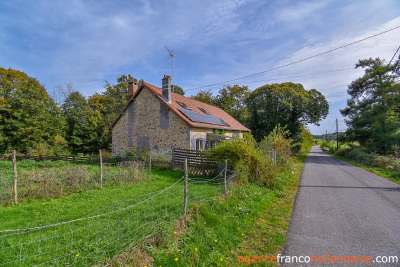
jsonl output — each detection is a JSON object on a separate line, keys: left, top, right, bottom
{"left": 112, "top": 88, "right": 190, "bottom": 155}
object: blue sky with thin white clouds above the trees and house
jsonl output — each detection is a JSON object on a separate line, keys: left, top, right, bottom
{"left": 0, "top": 0, "right": 400, "bottom": 134}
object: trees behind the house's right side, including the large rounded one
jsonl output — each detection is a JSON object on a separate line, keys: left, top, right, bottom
{"left": 193, "top": 82, "right": 329, "bottom": 150}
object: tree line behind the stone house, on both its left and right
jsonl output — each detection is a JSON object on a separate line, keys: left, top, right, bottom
{"left": 0, "top": 68, "right": 329, "bottom": 155}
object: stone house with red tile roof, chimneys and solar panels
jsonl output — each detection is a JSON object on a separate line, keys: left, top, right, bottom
{"left": 109, "top": 75, "right": 250, "bottom": 155}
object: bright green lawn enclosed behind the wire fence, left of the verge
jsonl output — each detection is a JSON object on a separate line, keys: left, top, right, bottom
{"left": 0, "top": 169, "right": 225, "bottom": 266}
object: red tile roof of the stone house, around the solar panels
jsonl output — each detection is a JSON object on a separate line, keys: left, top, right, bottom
{"left": 109, "top": 81, "right": 250, "bottom": 132}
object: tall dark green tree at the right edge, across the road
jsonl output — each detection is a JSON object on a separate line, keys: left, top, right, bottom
{"left": 341, "top": 58, "right": 400, "bottom": 154}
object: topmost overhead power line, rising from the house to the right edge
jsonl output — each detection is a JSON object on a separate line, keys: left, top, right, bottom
{"left": 186, "top": 26, "right": 400, "bottom": 91}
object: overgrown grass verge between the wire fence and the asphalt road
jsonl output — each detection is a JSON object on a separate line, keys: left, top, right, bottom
{"left": 114, "top": 152, "right": 308, "bottom": 266}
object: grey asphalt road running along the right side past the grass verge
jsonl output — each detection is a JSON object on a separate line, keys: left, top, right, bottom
{"left": 282, "top": 147, "right": 400, "bottom": 266}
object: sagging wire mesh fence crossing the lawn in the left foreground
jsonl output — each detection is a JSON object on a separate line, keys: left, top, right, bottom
{"left": 0, "top": 165, "right": 237, "bottom": 266}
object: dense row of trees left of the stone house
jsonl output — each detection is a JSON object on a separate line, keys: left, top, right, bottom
{"left": 0, "top": 68, "right": 136, "bottom": 155}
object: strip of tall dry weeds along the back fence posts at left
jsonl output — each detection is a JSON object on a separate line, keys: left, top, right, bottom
{"left": 0, "top": 161, "right": 147, "bottom": 205}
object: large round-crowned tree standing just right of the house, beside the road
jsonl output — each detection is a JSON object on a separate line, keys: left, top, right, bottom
{"left": 245, "top": 82, "right": 329, "bottom": 147}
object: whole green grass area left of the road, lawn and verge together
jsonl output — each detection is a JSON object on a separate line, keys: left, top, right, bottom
{"left": 0, "top": 150, "right": 306, "bottom": 266}
